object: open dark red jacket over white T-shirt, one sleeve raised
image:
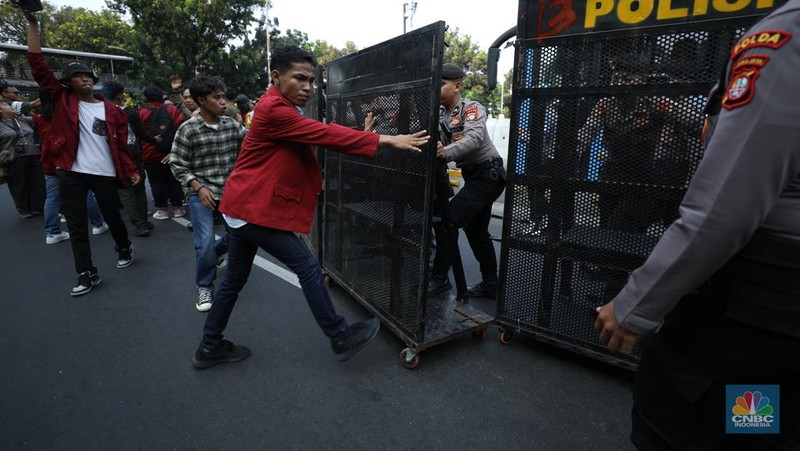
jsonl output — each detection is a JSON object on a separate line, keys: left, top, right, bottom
{"left": 25, "top": 52, "right": 138, "bottom": 186}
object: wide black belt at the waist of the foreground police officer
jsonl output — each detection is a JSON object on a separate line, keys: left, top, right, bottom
{"left": 708, "top": 233, "right": 800, "bottom": 338}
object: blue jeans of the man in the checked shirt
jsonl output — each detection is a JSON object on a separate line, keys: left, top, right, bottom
{"left": 187, "top": 194, "right": 230, "bottom": 288}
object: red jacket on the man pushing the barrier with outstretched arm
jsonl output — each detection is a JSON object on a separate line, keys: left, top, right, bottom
{"left": 220, "top": 86, "right": 379, "bottom": 233}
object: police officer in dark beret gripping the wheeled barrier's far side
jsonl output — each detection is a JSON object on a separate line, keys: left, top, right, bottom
{"left": 428, "top": 63, "right": 506, "bottom": 298}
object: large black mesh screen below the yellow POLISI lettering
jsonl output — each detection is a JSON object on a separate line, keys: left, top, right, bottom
{"left": 497, "top": 18, "right": 752, "bottom": 365}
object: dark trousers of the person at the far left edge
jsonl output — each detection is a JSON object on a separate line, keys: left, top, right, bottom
{"left": 8, "top": 154, "right": 47, "bottom": 214}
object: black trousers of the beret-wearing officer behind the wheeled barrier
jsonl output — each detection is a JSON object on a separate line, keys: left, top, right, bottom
{"left": 433, "top": 162, "right": 506, "bottom": 282}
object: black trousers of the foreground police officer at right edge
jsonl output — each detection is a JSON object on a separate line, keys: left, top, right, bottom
{"left": 631, "top": 237, "right": 800, "bottom": 450}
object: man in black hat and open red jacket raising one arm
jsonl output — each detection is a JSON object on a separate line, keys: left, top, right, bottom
{"left": 25, "top": 12, "right": 140, "bottom": 296}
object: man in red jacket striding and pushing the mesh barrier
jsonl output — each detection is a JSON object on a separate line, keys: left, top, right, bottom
{"left": 192, "top": 46, "right": 430, "bottom": 369}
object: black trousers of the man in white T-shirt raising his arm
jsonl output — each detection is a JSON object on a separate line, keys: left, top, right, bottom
{"left": 56, "top": 169, "right": 130, "bottom": 274}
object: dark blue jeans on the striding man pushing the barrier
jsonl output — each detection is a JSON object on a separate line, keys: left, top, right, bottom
{"left": 202, "top": 223, "right": 350, "bottom": 349}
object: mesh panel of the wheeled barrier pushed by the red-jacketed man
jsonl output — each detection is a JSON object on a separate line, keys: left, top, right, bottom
{"left": 323, "top": 22, "right": 444, "bottom": 340}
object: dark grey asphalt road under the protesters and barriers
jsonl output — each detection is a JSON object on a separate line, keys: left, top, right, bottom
{"left": 0, "top": 187, "right": 633, "bottom": 450}
